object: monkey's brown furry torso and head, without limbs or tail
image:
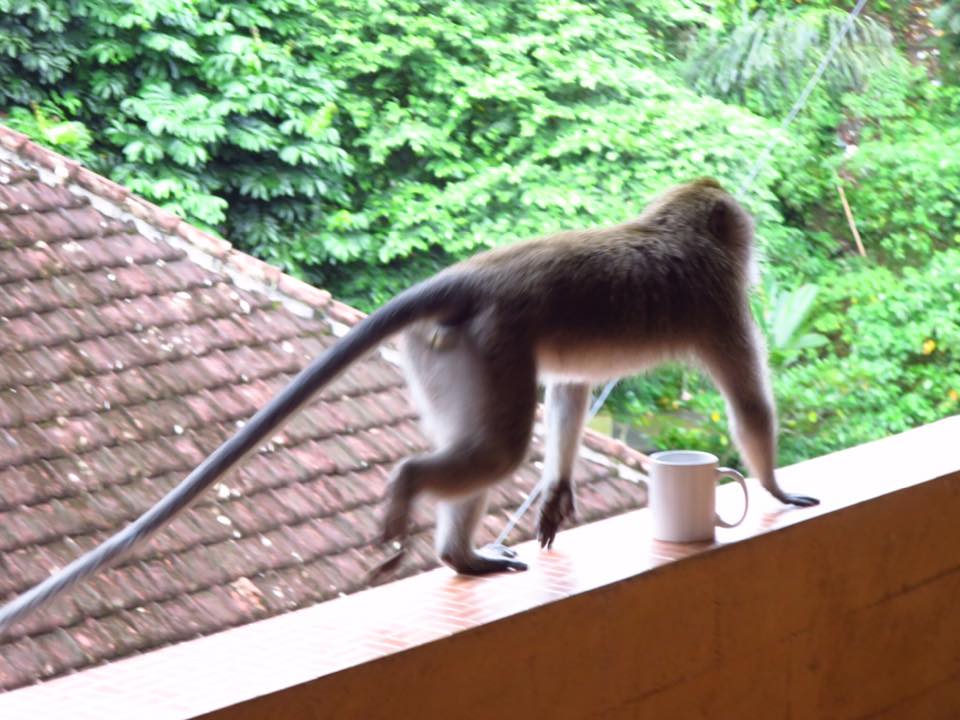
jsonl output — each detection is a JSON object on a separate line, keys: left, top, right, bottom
{"left": 452, "top": 186, "right": 751, "bottom": 379}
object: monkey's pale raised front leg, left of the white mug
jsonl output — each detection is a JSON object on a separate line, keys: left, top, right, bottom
{"left": 537, "top": 383, "right": 590, "bottom": 547}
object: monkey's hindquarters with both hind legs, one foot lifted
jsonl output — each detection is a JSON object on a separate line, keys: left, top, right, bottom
{"left": 384, "top": 324, "right": 536, "bottom": 574}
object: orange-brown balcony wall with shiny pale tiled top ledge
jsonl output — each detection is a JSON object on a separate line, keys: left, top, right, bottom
{"left": 0, "top": 417, "right": 960, "bottom": 720}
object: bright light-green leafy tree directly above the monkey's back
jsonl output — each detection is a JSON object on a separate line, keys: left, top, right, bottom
{"left": 308, "top": 0, "right": 765, "bottom": 270}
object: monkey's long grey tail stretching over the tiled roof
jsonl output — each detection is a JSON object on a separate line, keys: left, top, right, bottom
{"left": 0, "top": 273, "right": 473, "bottom": 637}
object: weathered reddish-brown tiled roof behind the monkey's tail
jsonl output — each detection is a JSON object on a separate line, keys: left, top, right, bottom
{"left": 0, "top": 127, "right": 643, "bottom": 690}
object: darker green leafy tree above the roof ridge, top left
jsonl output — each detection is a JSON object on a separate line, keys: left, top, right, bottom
{"left": 0, "top": 0, "right": 352, "bottom": 258}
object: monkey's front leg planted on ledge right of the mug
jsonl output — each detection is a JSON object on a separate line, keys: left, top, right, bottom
{"left": 700, "top": 321, "right": 820, "bottom": 507}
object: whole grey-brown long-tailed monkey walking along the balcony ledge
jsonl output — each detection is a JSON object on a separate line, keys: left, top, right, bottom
{"left": 0, "top": 179, "right": 818, "bottom": 633}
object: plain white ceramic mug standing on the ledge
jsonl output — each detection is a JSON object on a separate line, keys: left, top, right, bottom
{"left": 649, "top": 450, "right": 749, "bottom": 542}
